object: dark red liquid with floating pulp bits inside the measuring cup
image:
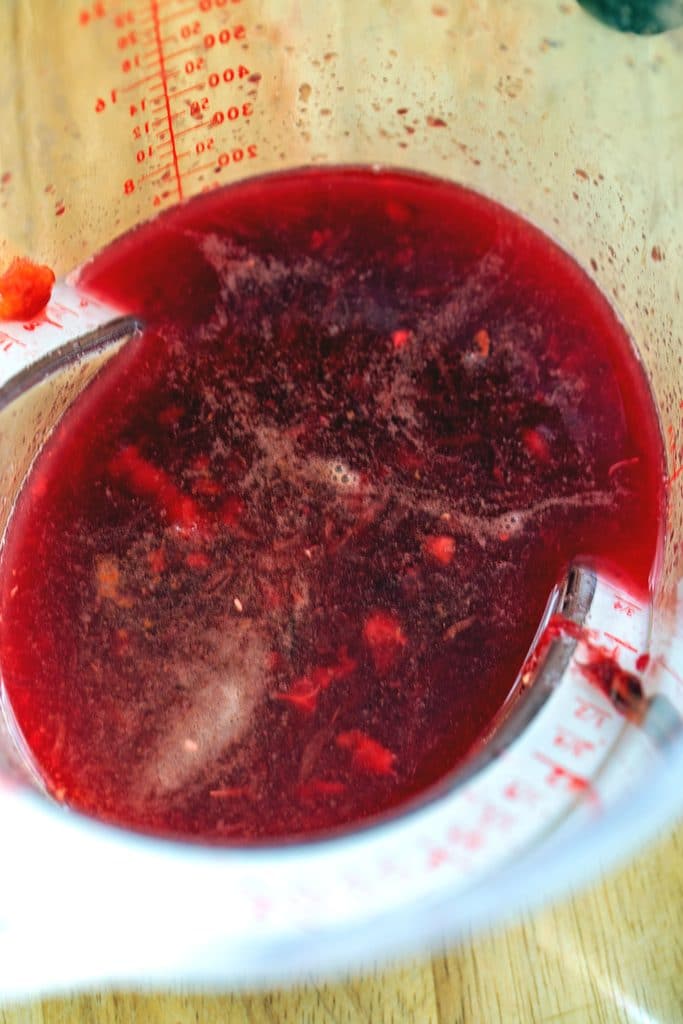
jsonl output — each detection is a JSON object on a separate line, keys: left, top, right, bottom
{"left": 0, "top": 170, "right": 663, "bottom": 842}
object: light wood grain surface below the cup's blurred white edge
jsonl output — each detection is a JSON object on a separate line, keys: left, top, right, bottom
{"left": 0, "top": 826, "right": 683, "bottom": 1024}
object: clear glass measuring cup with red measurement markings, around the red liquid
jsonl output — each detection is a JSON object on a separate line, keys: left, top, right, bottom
{"left": 0, "top": 0, "right": 682, "bottom": 989}
